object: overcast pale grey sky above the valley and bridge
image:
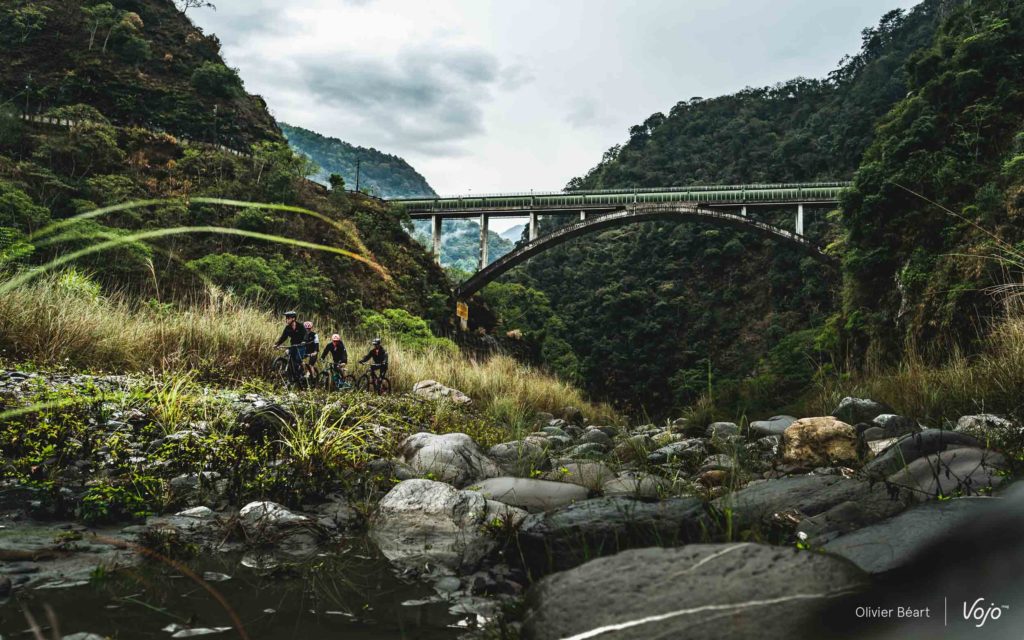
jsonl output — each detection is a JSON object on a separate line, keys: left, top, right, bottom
{"left": 189, "top": 0, "right": 916, "bottom": 201}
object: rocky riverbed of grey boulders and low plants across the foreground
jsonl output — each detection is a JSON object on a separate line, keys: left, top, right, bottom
{"left": 0, "top": 372, "right": 1021, "bottom": 638}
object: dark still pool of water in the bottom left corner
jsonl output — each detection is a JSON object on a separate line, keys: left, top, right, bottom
{"left": 0, "top": 541, "right": 476, "bottom": 640}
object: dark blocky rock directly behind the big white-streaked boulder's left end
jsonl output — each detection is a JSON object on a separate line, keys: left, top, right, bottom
{"left": 517, "top": 497, "right": 705, "bottom": 573}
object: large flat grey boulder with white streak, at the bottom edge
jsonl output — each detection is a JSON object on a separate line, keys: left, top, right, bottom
{"left": 522, "top": 543, "right": 867, "bottom": 640}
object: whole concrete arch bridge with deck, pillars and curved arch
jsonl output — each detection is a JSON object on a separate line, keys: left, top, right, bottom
{"left": 389, "top": 182, "right": 850, "bottom": 299}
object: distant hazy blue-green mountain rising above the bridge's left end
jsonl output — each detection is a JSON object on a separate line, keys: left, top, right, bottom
{"left": 279, "top": 122, "right": 437, "bottom": 198}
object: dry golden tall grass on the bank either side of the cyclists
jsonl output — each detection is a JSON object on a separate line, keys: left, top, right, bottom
{"left": 0, "top": 271, "right": 617, "bottom": 427}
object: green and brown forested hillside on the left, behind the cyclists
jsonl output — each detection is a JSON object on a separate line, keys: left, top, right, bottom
{"left": 0, "top": 0, "right": 450, "bottom": 323}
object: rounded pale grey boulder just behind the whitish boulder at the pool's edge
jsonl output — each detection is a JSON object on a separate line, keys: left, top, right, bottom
{"left": 399, "top": 433, "right": 502, "bottom": 486}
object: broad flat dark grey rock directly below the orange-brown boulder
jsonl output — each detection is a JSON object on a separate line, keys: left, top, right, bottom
{"left": 712, "top": 475, "right": 908, "bottom": 536}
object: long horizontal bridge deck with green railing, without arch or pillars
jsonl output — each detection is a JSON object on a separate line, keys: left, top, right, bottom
{"left": 389, "top": 182, "right": 850, "bottom": 218}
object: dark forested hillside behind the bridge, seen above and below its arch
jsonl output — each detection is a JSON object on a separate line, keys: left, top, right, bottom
{"left": 495, "top": 0, "right": 955, "bottom": 414}
